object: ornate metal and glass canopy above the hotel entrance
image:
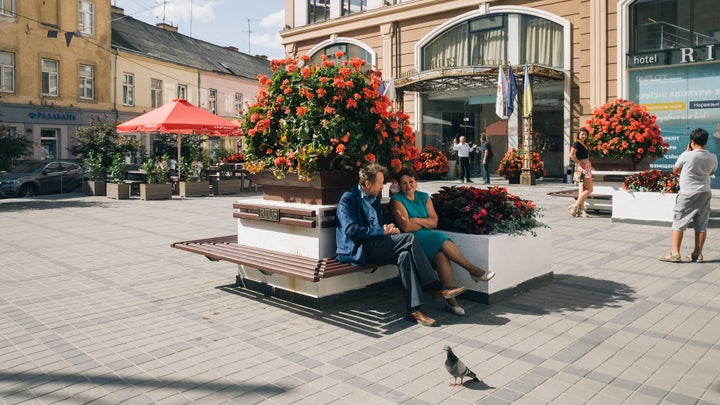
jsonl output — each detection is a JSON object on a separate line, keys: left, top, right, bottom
{"left": 395, "top": 65, "right": 564, "bottom": 93}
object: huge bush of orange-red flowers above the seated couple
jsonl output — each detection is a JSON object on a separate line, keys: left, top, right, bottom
{"left": 241, "top": 52, "right": 417, "bottom": 203}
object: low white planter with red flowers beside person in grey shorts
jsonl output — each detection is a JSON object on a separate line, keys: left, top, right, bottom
{"left": 612, "top": 170, "right": 680, "bottom": 225}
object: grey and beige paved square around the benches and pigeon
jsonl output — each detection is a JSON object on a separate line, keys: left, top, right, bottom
{"left": 0, "top": 181, "right": 720, "bottom": 405}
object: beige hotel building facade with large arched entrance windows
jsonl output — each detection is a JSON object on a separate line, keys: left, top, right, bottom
{"left": 281, "top": 0, "right": 720, "bottom": 188}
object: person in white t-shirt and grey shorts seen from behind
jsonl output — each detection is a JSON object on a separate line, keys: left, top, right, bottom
{"left": 660, "top": 128, "right": 718, "bottom": 263}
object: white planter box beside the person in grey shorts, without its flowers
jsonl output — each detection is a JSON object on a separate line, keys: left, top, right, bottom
{"left": 612, "top": 189, "right": 677, "bottom": 225}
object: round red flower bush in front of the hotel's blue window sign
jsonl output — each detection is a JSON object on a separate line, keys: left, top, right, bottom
{"left": 585, "top": 99, "right": 669, "bottom": 170}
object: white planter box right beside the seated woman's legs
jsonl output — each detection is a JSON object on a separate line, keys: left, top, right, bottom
{"left": 444, "top": 228, "right": 553, "bottom": 304}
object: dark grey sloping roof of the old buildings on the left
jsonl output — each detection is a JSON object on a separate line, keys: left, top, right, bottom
{"left": 112, "top": 13, "right": 271, "bottom": 80}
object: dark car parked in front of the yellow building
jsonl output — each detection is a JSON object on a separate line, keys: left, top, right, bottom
{"left": 0, "top": 160, "right": 84, "bottom": 197}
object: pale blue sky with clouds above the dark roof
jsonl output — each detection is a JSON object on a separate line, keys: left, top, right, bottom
{"left": 111, "top": 0, "right": 285, "bottom": 59}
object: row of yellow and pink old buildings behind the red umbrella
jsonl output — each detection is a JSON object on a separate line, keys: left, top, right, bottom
{"left": 0, "top": 0, "right": 270, "bottom": 163}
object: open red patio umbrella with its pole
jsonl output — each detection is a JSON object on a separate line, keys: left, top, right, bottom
{"left": 116, "top": 98, "right": 242, "bottom": 175}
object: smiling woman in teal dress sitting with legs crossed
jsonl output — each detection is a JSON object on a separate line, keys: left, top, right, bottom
{"left": 390, "top": 168, "right": 495, "bottom": 315}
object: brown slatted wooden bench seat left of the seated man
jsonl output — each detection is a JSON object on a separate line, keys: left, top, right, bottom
{"left": 171, "top": 235, "right": 378, "bottom": 283}
